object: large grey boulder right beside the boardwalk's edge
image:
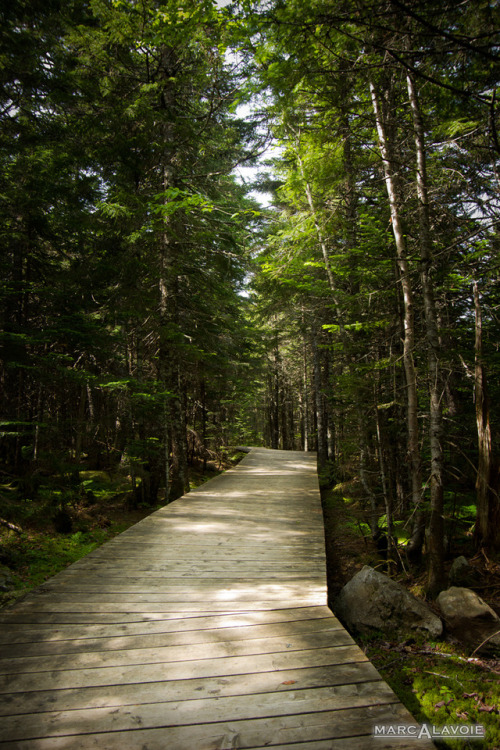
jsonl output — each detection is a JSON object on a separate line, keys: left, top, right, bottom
{"left": 335, "top": 565, "right": 443, "bottom": 638}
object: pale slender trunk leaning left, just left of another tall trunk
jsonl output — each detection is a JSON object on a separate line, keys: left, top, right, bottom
{"left": 370, "top": 83, "right": 425, "bottom": 560}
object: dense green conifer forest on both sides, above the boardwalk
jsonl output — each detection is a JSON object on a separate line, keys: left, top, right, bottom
{"left": 0, "top": 0, "right": 500, "bottom": 596}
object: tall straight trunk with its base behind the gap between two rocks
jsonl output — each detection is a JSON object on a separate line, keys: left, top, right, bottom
{"left": 407, "top": 75, "right": 444, "bottom": 596}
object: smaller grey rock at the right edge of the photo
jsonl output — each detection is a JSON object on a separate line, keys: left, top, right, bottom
{"left": 437, "top": 586, "right": 500, "bottom": 651}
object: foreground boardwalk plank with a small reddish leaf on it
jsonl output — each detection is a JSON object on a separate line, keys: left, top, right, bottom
{"left": 0, "top": 661, "right": 379, "bottom": 715}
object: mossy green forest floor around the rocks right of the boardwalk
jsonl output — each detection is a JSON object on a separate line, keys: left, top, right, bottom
{"left": 322, "top": 487, "right": 500, "bottom": 750}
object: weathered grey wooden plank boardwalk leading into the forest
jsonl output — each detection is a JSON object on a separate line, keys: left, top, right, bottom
{"left": 0, "top": 449, "right": 431, "bottom": 750}
